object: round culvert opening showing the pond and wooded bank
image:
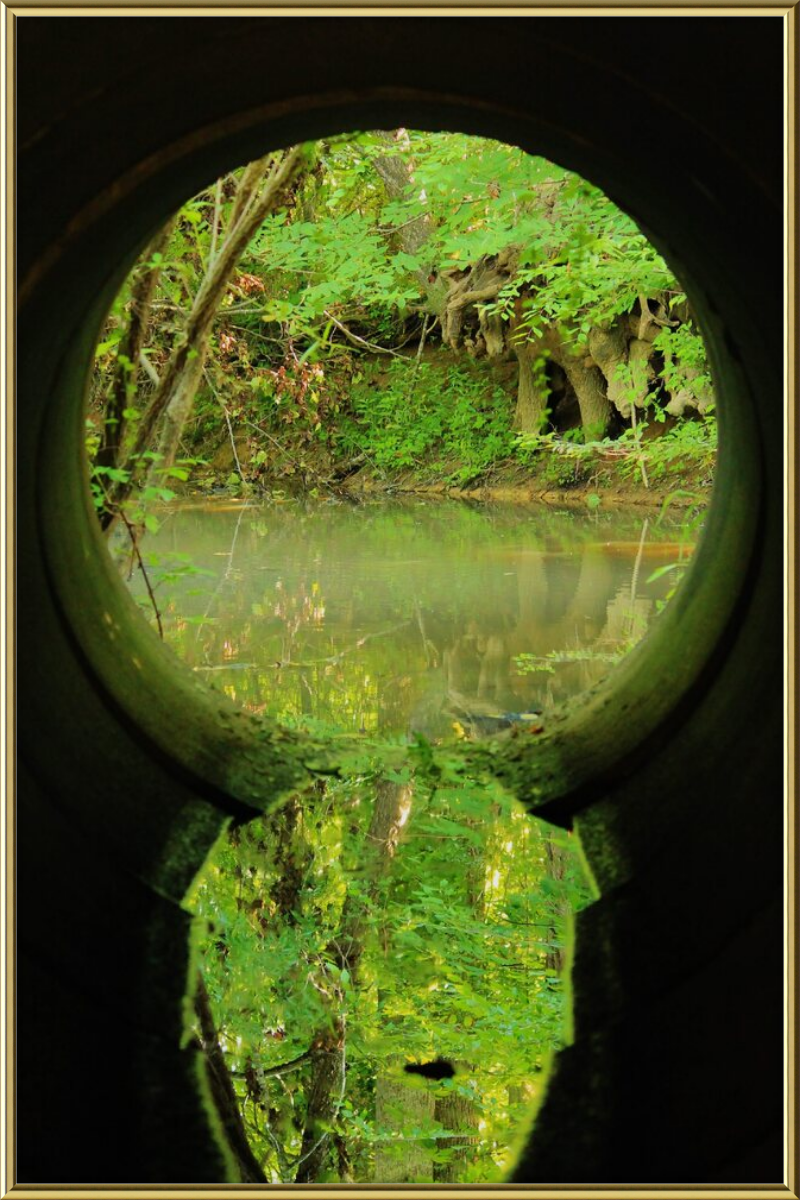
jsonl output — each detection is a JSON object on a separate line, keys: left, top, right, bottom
{"left": 86, "top": 130, "right": 716, "bottom": 737}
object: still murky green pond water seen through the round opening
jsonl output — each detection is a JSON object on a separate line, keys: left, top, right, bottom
{"left": 131, "top": 500, "right": 692, "bottom": 737}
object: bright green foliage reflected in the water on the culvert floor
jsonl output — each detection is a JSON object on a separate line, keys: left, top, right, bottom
{"left": 185, "top": 755, "right": 589, "bottom": 1182}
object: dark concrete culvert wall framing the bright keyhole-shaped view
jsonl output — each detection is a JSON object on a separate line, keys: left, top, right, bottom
{"left": 13, "top": 16, "right": 783, "bottom": 1183}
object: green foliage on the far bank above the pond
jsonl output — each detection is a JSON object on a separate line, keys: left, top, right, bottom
{"left": 92, "top": 130, "right": 712, "bottom": 503}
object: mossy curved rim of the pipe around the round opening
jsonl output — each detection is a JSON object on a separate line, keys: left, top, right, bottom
{"left": 38, "top": 94, "right": 760, "bottom": 844}
